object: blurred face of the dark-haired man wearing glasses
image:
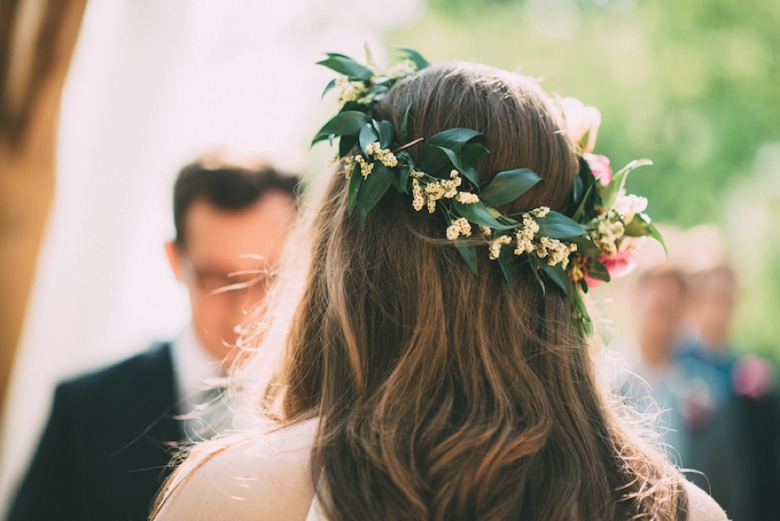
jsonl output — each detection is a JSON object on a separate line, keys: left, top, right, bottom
{"left": 166, "top": 191, "right": 296, "bottom": 362}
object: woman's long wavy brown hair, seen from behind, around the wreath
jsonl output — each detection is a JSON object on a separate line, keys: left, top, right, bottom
{"left": 269, "top": 62, "right": 685, "bottom": 520}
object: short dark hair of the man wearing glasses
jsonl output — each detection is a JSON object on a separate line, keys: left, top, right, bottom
{"left": 173, "top": 160, "right": 300, "bottom": 246}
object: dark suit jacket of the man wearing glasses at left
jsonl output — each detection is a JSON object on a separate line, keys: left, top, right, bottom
{"left": 9, "top": 344, "right": 184, "bottom": 521}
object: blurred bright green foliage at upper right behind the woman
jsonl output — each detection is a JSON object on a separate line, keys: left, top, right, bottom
{"left": 387, "top": 0, "right": 780, "bottom": 355}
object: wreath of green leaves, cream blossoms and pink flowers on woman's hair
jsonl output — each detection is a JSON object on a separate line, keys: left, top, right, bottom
{"left": 312, "top": 49, "right": 665, "bottom": 337}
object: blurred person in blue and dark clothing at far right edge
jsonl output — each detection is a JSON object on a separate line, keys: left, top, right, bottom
{"left": 677, "top": 263, "right": 780, "bottom": 521}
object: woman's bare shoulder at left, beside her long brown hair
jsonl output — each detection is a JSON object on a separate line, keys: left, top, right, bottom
{"left": 154, "top": 421, "right": 316, "bottom": 521}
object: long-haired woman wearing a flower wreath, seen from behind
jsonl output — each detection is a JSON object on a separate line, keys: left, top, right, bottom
{"left": 155, "top": 51, "right": 725, "bottom": 521}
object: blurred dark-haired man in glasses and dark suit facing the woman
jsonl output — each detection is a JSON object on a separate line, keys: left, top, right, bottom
{"left": 9, "top": 157, "right": 298, "bottom": 521}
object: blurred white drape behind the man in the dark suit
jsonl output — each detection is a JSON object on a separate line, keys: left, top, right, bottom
{"left": 0, "top": 0, "right": 417, "bottom": 512}
